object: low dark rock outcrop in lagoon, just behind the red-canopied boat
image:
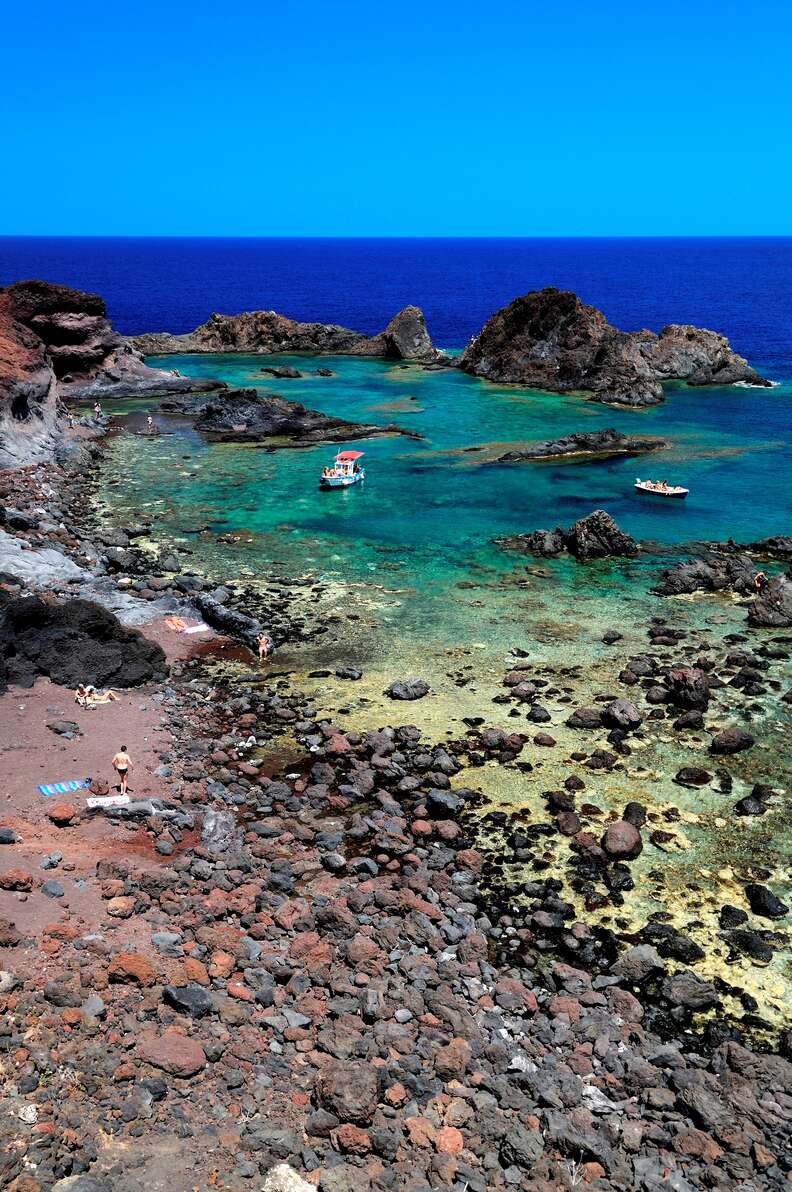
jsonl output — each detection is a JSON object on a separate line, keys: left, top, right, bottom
{"left": 181, "top": 389, "right": 419, "bottom": 446}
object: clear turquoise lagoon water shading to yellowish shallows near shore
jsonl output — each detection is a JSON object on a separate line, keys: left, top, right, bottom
{"left": 99, "top": 355, "right": 792, "bottom": 1018}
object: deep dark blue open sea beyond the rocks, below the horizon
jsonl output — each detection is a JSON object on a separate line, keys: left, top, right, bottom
{"left": 0, "top": 237, "right": 792, "bottom": 375}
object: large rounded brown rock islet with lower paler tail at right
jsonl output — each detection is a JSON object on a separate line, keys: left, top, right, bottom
{"left": 458, "top": 287, "right": 768, "bottom": 406}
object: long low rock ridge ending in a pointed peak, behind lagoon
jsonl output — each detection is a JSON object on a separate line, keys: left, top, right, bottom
{"left": 129, "top": 306, "right": 439, "bottom": 361}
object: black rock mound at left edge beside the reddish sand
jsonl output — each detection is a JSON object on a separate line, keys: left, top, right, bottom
{"left": 0, "top": 590, "right": 167, "bottom": 691}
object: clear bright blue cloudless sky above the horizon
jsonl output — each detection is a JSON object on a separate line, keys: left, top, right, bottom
{"left": 0, "top": 0, "right": 792, "bottom": 236}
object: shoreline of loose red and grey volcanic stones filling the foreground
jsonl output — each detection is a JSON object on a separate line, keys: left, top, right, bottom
{"left": 0, "top": 395, "right": 792, "bottom": 1192}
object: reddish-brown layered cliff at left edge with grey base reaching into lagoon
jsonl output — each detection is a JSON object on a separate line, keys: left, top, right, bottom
{"left": 0, "top": 281, "right": 219, "bottom": 467}
